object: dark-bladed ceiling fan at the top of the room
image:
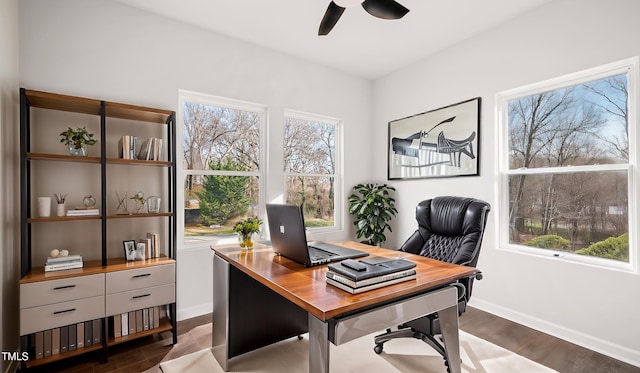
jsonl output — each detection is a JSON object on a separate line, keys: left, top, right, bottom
{"left": 318, "top": 0, "right": 409, "bottom": 35}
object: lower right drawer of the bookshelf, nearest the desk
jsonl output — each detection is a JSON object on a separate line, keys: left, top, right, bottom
{"left": 106, "top": 284, "right": 176, "bottom": 316}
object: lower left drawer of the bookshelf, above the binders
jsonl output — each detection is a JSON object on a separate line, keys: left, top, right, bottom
{"left": 20, "top": 295, "right": 104, "bottom": 335}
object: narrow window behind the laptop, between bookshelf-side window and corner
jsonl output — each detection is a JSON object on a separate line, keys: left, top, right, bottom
{"left": 284, "top": 111, "right": 342, "bottom": 229}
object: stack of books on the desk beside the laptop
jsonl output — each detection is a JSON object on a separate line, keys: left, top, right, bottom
{"left": 327, "top": 256, "right": 416, "bottom": 294}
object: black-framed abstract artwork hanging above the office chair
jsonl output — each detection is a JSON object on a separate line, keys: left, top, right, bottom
{"left": 387, "top": 97, "right": 480, "bottom": 180}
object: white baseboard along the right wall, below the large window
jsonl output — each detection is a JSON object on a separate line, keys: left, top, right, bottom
{"left": 469, "top": 298, "right": 640, "bottom": 367}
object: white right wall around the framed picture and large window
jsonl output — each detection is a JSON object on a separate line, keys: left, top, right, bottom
{"left": 373, "top": 0, "right": 640, "bottom": 366}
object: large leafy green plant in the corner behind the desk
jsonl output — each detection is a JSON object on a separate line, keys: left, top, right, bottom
{"left": 349, "top": 184, "right": 398, "bottom": 246}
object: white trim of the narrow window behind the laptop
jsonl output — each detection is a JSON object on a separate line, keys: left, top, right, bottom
{"left": 282, "top": 109, "right": 344, "bottom": 234}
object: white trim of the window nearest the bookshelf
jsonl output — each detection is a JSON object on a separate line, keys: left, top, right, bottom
{"left": 176, "top": 89, "right": 269, "bottom": 250}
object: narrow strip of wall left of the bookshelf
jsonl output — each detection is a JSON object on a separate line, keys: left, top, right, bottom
{"left": 0, "top": 0, "right": 20, "bottom": 372}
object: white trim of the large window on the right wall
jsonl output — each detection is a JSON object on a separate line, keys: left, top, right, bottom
{"left": 495, "top": 57, "right": 640, "bottom": 273}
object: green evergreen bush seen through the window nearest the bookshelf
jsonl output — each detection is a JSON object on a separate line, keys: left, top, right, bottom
{"left": 196, "top": 159, "right": 251, "bottom": 225}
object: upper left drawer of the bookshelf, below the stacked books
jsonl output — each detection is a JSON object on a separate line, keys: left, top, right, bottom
{"left": 20, "top": 273, "right": 104, "bottom": 309}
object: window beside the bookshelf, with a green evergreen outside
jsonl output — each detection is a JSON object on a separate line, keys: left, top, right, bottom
{"left": 177, "top": 91, "right": 266, "bottom": 246}
